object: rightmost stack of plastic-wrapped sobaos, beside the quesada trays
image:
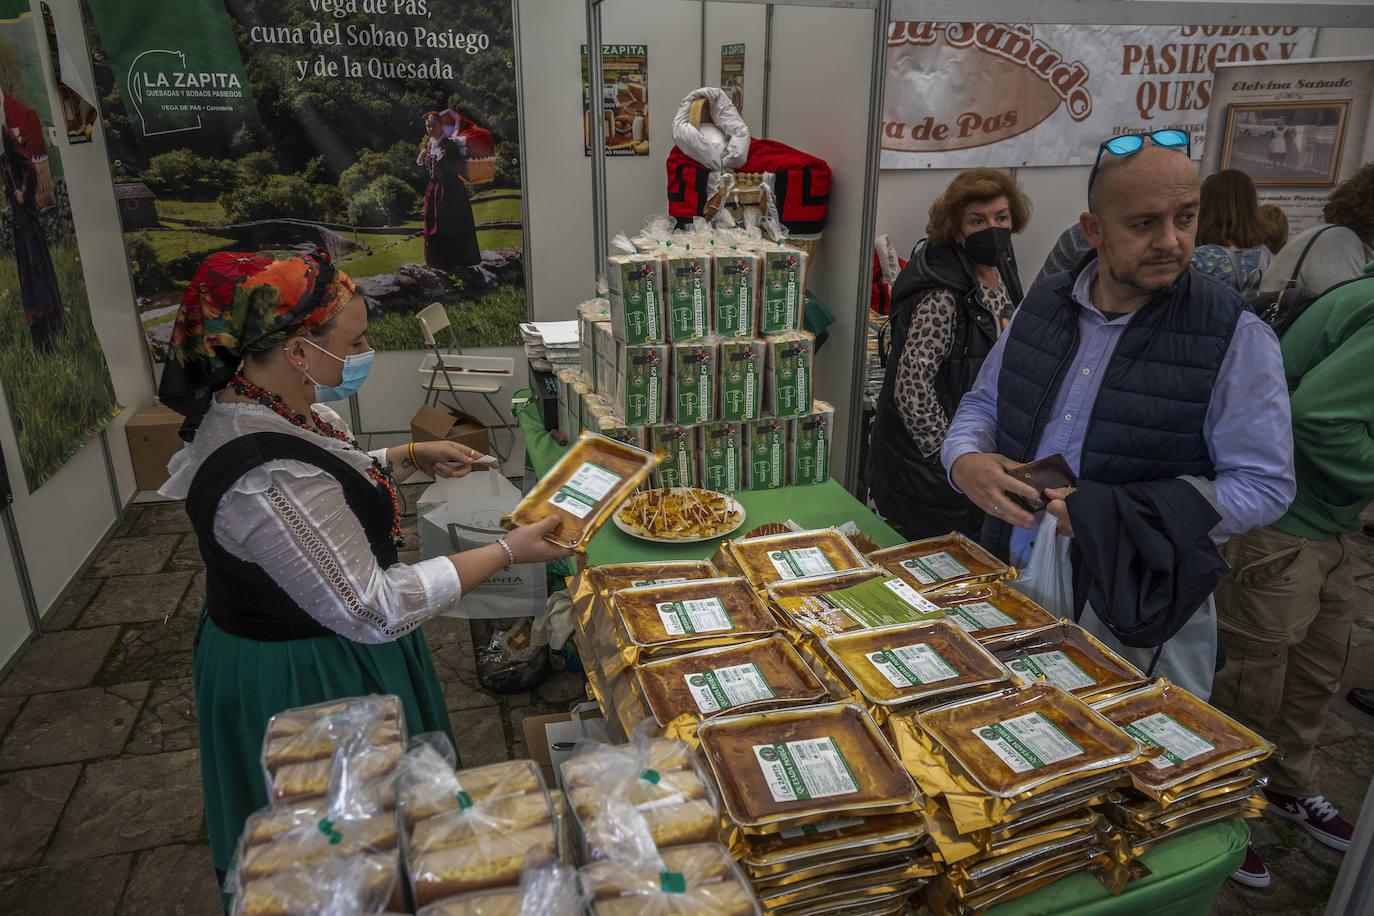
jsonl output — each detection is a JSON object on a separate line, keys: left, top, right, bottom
{"left": 559, "top": 735, "right": 758, "bottom": 916}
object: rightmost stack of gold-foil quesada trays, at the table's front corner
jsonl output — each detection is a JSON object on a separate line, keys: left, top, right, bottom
{"left": 1094, "top": 680, "right": 1274, "bottom": 856}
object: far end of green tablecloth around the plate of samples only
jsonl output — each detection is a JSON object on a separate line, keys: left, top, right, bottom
{"left": 517, "top": 404, "right": 901, "bottom": 566}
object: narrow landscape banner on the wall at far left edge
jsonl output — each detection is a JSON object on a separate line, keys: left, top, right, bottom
{"left": 0, "top": 0, "right": 120, "bottom": 493}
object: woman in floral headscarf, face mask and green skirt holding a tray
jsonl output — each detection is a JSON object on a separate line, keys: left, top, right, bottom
{"left": 159, "top": 251, "right": 567, "bottom": 884}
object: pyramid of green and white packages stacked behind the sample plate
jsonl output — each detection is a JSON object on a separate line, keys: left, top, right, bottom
{"left": 546, "top": 222, "right": 835, "bottom": 493}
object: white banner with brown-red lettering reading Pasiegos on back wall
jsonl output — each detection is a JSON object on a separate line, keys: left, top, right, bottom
{"left": 882, "top": 22, "right": 1316, "bottom": 169}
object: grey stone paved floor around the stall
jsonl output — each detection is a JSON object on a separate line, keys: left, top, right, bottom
{"left": 0, "top": 486, "right": 1374, "bottom": 916}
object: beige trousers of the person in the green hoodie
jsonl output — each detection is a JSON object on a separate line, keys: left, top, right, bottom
{"left": 1212, "top": 527, "right": 1355, "bottom": 798}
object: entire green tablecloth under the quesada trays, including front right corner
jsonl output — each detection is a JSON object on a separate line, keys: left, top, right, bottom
{"left": 517, "top": 405, "right": 1250, "bottom": 916}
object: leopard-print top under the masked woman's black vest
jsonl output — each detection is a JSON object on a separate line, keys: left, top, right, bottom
{"left": 893, "top": 283, "right": 1017, "bottom": 457}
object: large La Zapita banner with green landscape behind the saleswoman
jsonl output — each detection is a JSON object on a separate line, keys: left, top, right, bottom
{"left": 82, "top": 0, "right": 526, "bottom": 360}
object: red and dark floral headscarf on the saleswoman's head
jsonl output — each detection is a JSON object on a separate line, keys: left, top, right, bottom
{"left": 158, "top": 251, "right": 353, "bottom": 439}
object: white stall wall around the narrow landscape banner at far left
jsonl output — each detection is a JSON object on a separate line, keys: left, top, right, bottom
{"left": 0, "top": 0, "right": 153, "bottom": 666}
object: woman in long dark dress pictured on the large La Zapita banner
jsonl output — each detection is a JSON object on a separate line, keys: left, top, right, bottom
{"left": 415, "top": 108, "right": 482, "bottom": 273}
